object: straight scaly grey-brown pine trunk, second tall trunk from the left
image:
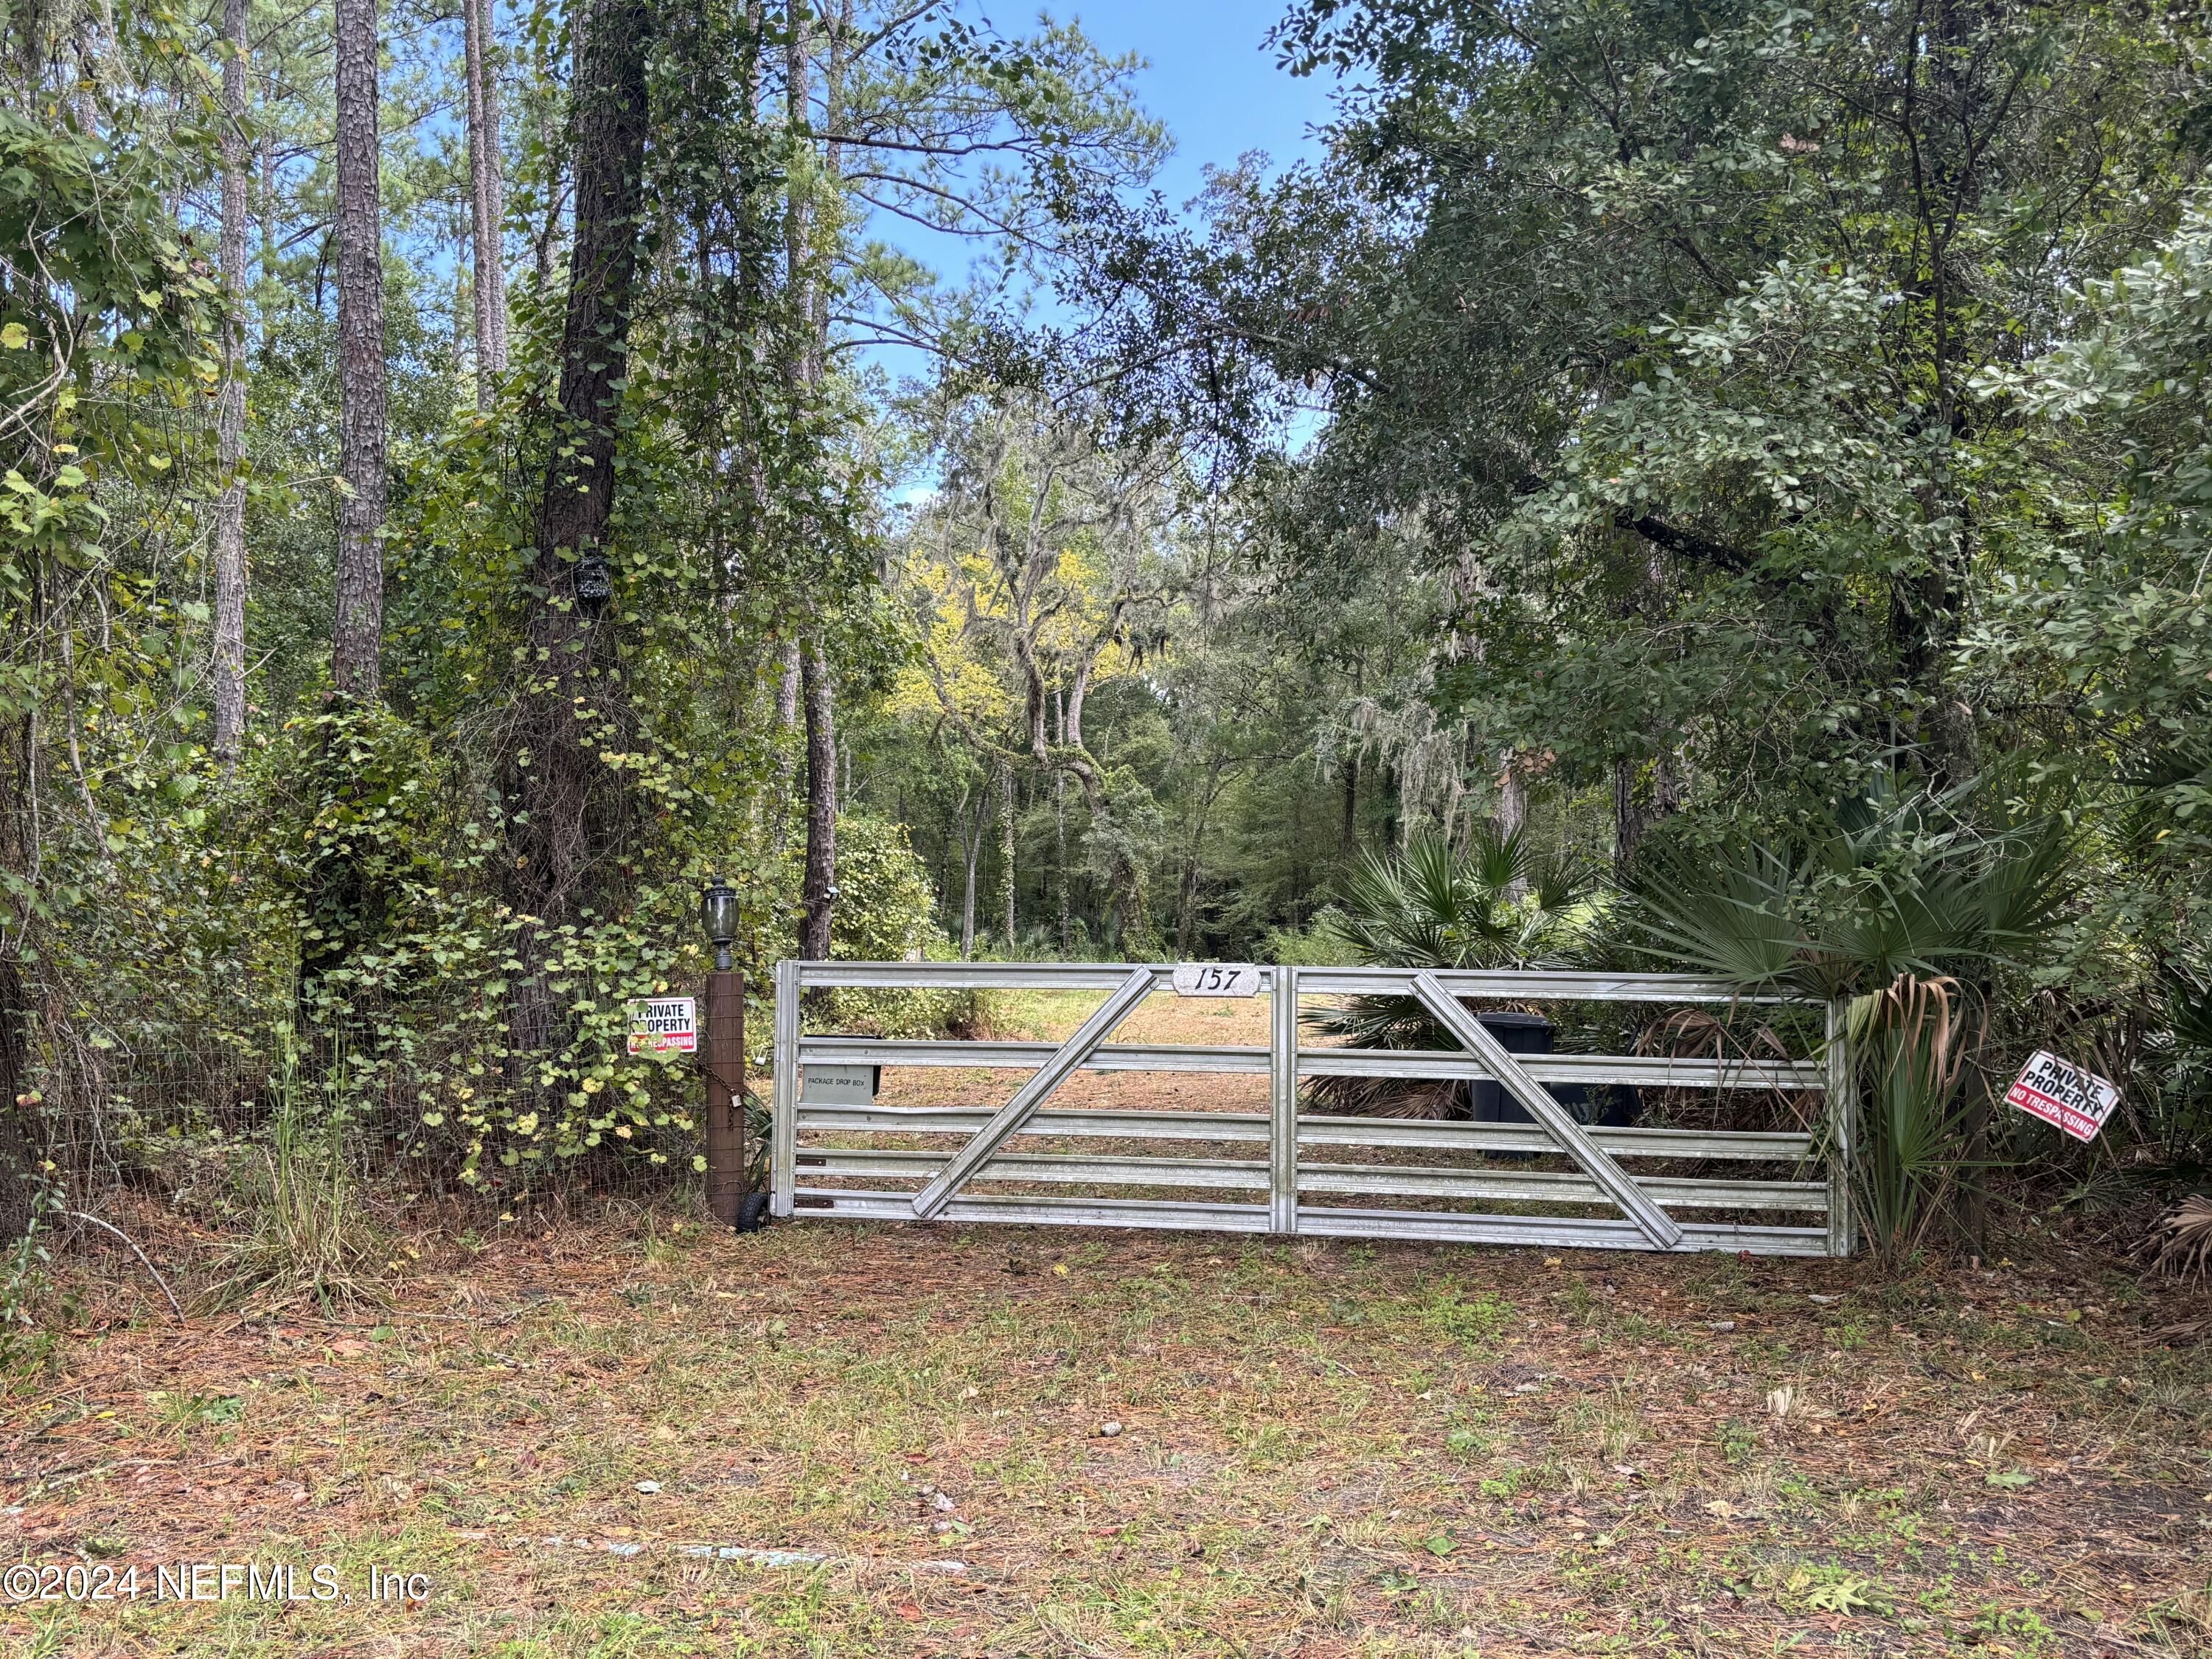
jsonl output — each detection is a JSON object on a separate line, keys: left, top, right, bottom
{"left": 330, "top": 0, "right": 385, "bottom": 703}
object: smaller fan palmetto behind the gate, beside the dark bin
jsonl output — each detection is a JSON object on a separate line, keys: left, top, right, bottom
{"left": 1305, "top": 825, "right": 1593, "bottom": 1117}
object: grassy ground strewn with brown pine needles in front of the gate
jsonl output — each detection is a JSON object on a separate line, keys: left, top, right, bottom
{"left": 0, "top": 1214, "right": 2212, "bottom": 1659}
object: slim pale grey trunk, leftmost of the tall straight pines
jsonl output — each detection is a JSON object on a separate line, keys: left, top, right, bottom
{"left": 210, "top": 0, "right": 248, "bottom": 772}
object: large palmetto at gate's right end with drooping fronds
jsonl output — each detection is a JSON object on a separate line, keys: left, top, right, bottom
{"left": 1630, "top": 792, "right": 2073, "bottom": 1256}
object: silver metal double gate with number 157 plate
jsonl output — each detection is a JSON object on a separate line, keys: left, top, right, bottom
{"left": 770, "top": 962, "right": 1854, "bottom": 1256}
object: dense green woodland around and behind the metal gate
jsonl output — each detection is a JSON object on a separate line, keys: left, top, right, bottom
{"left": 0, "top": 0, "right": 2212, "bottom": 1310}
